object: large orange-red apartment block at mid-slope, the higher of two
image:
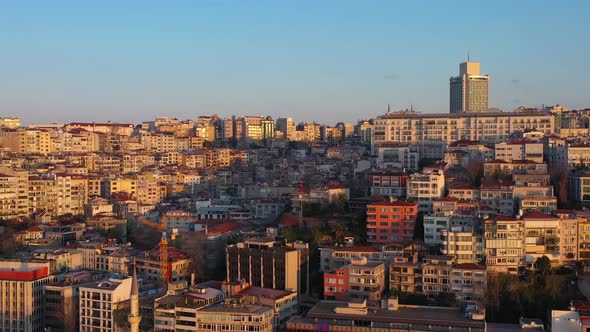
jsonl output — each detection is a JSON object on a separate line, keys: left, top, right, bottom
{"left": 367, "top": 198, "right": 418, "bottom": 244}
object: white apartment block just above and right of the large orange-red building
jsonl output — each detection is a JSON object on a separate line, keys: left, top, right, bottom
{"left": 407, "top": 169, "right": 445, "bottom": 212}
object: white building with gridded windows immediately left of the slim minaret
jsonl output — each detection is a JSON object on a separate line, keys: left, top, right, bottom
{"left": 79, "top": 275, "right": 132, "bottom": 332}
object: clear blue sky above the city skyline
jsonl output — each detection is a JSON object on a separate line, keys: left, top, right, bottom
{"left": 0, "top": 0, "right": 590, "bottom": 124}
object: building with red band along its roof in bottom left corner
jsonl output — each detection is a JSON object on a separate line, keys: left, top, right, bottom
{"left": 0, "top": 261, "right": 57, "bottom": 332}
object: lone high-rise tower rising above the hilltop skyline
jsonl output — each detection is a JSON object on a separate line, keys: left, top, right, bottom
{"left": 450, "top": 56, "right": 490, "bottom": 113}
